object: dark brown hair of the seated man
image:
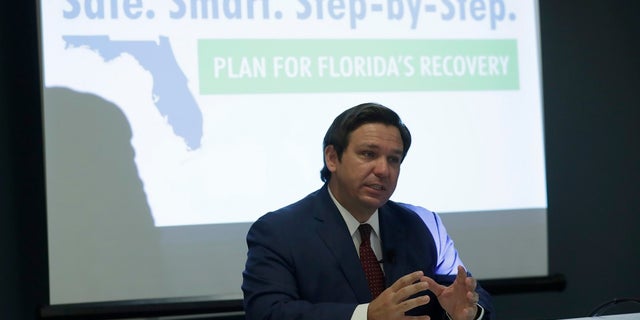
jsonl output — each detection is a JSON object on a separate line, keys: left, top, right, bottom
{"left": 320, "top": 102, "right": 411, "bottom": 182}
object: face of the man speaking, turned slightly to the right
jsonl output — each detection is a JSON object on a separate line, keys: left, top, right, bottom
{"left": 325, "top": 123, "right": 403, "bottom": 222}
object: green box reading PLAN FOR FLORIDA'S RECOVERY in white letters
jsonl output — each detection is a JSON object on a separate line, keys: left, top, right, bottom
{"left": 198, "top": 39, "right": 519, "bottom": 94}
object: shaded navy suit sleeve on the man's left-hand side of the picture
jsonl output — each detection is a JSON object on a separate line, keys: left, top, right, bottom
{"left": 242, "top": 218, "right": 357, "bottom": 320}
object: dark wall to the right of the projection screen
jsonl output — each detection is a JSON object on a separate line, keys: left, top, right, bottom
{"left": 495, "top": 0, "right": 640, "bottom": 319}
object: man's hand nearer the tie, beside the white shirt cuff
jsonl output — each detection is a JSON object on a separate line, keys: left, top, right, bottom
{"left": 367, "top": 271, "right": 435, "bottom": 320}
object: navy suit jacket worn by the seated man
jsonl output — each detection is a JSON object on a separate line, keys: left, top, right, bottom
{"left": 242, "top": 184, "right": 490, "bottom": 320}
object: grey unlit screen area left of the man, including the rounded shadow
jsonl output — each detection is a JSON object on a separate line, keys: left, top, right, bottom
{"left": 44, "top": 88, "right": 250, "bottom": 304}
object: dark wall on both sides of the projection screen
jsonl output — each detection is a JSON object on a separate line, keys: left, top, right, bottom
{"left": 0, "top": 0, "right": 640, "bottom": 320}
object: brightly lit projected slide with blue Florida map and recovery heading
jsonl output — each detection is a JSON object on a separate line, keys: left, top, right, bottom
{"left": 41, "top": 0, "right": 546, "bottom": 226}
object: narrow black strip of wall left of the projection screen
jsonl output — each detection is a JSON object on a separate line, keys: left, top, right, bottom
{"left": 0, "top": 1, "right": 48, "bottom": 320}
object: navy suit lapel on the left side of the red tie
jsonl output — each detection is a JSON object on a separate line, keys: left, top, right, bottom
{"left": 314, "top": 185, "right": 371, "bottom": 303}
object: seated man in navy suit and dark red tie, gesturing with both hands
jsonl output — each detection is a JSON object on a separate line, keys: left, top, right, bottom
{"left": 242, "top": 103, "right": 492, "bottom": 320}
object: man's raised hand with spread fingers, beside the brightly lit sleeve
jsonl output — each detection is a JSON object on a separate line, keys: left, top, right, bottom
{"left": 425, "top": 266, "right": 479, "bottom": 320}
